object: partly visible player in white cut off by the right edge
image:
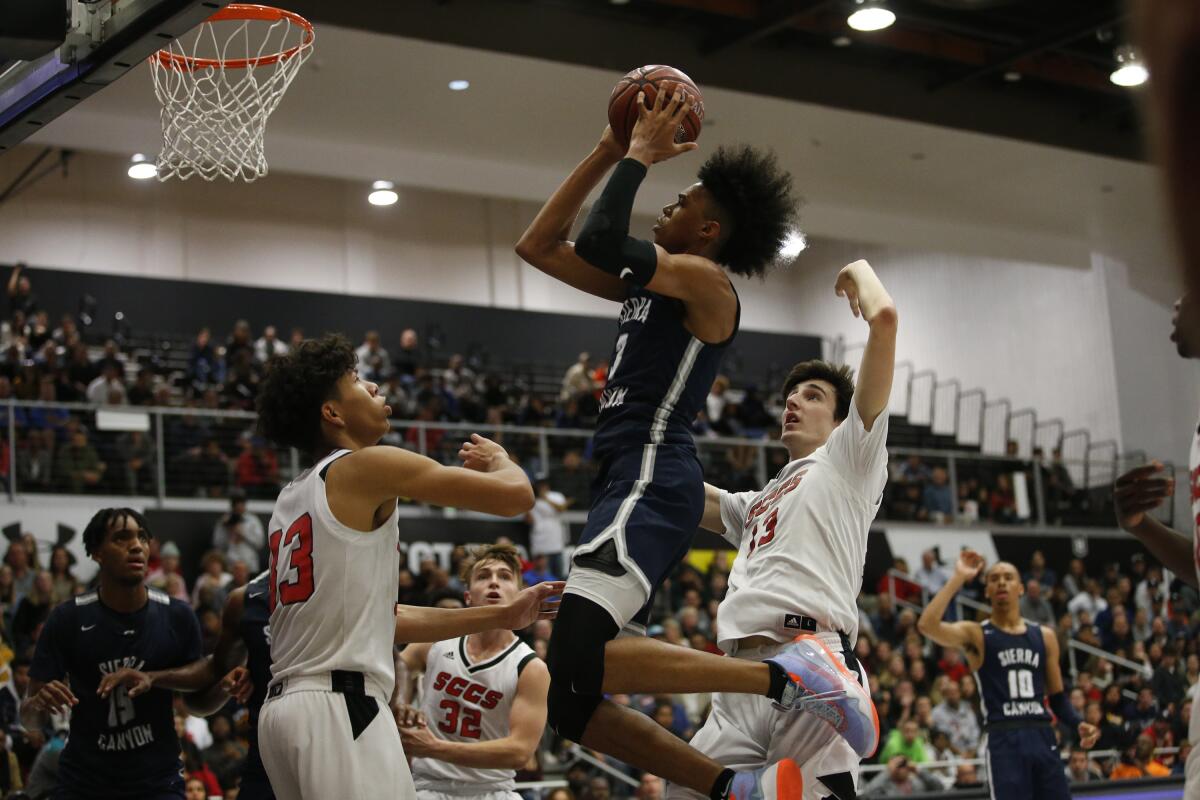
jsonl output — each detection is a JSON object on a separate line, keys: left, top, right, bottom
{"left": 1112, "top": 293, "right": 1200, "bottom": 800}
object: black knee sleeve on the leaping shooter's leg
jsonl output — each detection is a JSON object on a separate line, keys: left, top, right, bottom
{"left": 546, "top": 595, "right": 618, "bottom": 741}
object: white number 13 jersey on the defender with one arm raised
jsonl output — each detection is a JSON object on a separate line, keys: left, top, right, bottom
{"left": 718, "top": 403, "right": 888, "bottom": 652}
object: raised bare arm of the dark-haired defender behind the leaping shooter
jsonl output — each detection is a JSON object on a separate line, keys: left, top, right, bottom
{"left": 834, "top": 260, "right": 899, "bottom": 431}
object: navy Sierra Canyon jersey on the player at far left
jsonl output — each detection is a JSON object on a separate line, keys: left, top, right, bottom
{"left": 29, "top": 589, "right": 204, "bottom": 798}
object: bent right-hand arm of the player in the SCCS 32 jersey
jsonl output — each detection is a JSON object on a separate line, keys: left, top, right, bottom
{"left": 400, "top": 658, "right": 550, "bottom": 770}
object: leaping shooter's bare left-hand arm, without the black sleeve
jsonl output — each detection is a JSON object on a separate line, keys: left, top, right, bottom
{"left": 516, "top": 128, "right": 626, "bottom": 302}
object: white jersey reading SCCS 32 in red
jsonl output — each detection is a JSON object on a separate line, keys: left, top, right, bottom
{"left": 413, "top": 637, "right": 538, "bottom": 795}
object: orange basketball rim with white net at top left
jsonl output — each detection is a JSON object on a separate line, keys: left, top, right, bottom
{"left": 150, "top": 4, "right": 316, "bottom": 182}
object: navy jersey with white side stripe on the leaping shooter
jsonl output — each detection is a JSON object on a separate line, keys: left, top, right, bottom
{"left": 594, "top": 287, "right": 742, "bottom": 457}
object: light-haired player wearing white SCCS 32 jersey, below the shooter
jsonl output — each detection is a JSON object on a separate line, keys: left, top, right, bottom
{"left": 396, "top": 545, "right": 550, "bottom": 800}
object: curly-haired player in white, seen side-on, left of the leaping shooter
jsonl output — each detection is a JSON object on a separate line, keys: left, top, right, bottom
{"left": 258, "top": 336, "right": 533, "bottom": 800}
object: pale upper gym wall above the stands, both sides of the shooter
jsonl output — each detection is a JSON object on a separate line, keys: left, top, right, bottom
{"left": 0, "top": 145, "right": 1176, "bottom": 458}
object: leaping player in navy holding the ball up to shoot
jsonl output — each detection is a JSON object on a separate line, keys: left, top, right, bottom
{"left": 517, "top": 85, "right": 873, "bottom": 800}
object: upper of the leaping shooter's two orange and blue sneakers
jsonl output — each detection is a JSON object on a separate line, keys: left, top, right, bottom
{"left": 767, "top": 633, "right": 880, "bottom": 758}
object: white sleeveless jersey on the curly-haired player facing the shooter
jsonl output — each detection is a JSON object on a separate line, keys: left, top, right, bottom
{"left": 269, "top": 450, "right": 400, "bottom": 697}
